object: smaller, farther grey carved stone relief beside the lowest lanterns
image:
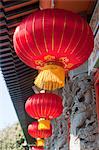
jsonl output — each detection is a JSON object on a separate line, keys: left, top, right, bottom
{"left": 46, "top": 115, "right": 68, "bottom": 150}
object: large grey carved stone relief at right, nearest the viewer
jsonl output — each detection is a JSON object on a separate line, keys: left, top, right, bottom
{"left": 62, "top": 75, "right": 99, "bottom": 150}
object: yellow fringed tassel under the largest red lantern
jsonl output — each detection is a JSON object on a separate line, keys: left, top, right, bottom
{"left": 34, "top": 65, "right": 65, "bottom": 90}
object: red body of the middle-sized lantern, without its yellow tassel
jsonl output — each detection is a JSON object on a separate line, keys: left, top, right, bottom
{"left": 25, "top": 93, "right": 63, "bottom": 119}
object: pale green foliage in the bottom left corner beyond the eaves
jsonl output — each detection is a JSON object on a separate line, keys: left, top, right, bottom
{"left": 0, "top": 123, "right": 25, "bottom": 150}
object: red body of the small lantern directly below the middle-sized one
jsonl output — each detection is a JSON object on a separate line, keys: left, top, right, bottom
{"left": 28, "top": 122, "right": 52, "bottom": 138}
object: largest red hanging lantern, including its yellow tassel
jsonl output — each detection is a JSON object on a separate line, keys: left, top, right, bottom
{"left": 13, "top": 9, "right": 94, "bottom": 90}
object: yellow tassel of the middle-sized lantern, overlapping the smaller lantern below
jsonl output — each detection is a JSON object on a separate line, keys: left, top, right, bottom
{"left": 38, "top": 118, "right": 50, "bottom": 130}
